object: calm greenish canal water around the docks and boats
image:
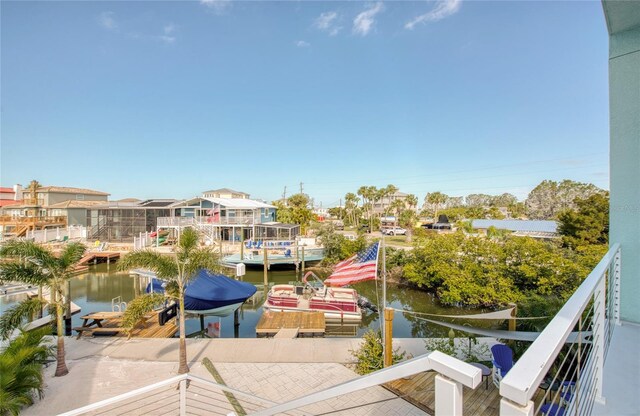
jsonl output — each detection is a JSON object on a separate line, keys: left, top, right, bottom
{"left": 0, "top": 264, "right": 500, "bottom": 338}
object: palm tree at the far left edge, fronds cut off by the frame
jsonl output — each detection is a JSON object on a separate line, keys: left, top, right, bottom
{"left": 0, "top": 241, "right": 86, "bottom": 377}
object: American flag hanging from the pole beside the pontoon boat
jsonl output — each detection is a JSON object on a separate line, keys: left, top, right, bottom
{"left": 324, "top": 242, "right": 380, "bottom": 286}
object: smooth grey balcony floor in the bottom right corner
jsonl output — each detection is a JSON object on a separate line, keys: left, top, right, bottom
{"left": 593, "top": 322, "right": 640, "bottom": 416}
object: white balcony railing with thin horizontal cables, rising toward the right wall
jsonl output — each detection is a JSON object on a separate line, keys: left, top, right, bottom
{"left": 500, "top": 244, "right": 621, "bottom": 416}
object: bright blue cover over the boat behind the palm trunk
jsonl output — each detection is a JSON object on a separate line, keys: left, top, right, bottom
{"left": 147, "top": 269, "right": 257, "bottom": 311}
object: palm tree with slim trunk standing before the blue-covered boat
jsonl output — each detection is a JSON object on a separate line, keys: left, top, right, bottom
{"left": 118, "top": 228, "right": 220, "bottom": 374}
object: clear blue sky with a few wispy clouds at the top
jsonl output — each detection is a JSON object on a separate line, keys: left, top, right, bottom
{"left": 0, "top": 0, "right": 609, "bottom": 206}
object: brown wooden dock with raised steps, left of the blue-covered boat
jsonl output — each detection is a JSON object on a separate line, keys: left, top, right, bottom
{"left": 73, "top": 311, "right": 178, "bottom": 338}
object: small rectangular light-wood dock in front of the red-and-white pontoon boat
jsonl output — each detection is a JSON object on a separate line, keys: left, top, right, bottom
{"left": 256, "top": 311, "right": 325, "bottom": 338}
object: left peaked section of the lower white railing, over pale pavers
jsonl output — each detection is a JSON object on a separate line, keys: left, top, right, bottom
{"left": 60, "top": 374, "right": 276, "bottom": 416}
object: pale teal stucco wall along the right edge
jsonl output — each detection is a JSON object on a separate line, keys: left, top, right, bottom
{"left": 609, "top": 28, "right": 640, "bottom": 323}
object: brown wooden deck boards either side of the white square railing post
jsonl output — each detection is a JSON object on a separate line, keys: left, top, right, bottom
{"left": 385, "top": 371, "right": 500, "bottom": 416}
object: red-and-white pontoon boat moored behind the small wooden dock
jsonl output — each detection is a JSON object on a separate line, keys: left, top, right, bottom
{"left": 263, "top": 272, "right": 362, "bottom": 321}
